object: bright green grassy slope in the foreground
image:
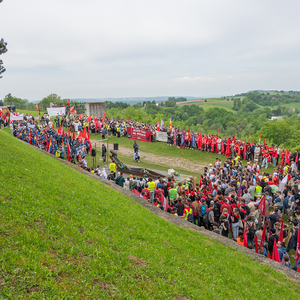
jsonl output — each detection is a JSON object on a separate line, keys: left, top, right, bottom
{"left": 0, "top": 130, "right": 298, "bottom": 299}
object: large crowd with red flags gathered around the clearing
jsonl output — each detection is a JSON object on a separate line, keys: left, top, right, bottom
{"left": 2, "top": 110, "right": 300, "bottom": 270}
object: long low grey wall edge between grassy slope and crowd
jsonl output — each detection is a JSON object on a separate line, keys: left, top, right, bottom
{"left": 20, "top": 140, "right": 300, "bottom": 283}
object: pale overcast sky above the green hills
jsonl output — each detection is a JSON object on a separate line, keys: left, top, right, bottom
{"left": 0, "top": 0, "right": 300, "bottom": 101}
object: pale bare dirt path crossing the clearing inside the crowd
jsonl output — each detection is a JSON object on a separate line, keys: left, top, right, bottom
{"left": 91, "top": 139, "right": 207, "bottom": 173}
